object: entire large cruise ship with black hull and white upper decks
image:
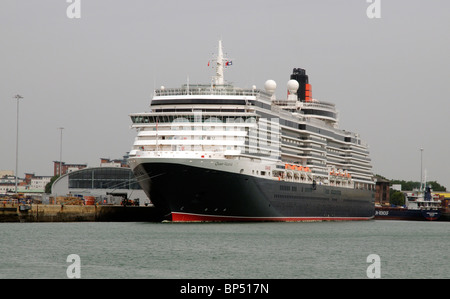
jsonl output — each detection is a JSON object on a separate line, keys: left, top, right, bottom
{"left": 128, "top": 41, "right": 375, "bottom": 222}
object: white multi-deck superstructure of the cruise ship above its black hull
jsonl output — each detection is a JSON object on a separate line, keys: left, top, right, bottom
{"left": 129, "top": 41, "right": 374, "bottom": 190}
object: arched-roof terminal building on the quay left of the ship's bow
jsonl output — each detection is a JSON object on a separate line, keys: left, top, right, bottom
{"left": 52, "top": 159, "right": 151, "bottom": 205}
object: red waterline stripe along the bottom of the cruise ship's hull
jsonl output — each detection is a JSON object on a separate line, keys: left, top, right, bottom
{"left": 172, "top": 213, "right": 373, "bottom": 222}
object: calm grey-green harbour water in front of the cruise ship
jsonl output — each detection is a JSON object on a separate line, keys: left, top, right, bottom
{"left": 0, "top": 221, "right": 450, "bottom": 279}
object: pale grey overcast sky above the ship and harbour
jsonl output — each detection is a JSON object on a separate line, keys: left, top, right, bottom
{"left": 0, "top": 0, "right": 450, "bottom": 189}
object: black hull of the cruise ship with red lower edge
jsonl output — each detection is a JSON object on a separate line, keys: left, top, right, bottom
{"left": 133, "top": 162, "right": 375, "bottom": 222}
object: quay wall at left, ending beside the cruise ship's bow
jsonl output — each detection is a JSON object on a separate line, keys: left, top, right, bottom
{"left": 0, "top": 204, "right": 163, "bottom": 222}
